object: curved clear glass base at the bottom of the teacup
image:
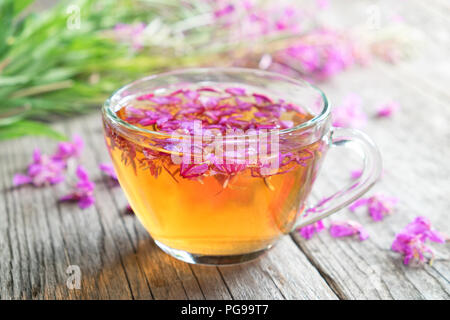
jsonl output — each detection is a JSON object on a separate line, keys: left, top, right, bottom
{"left": 154, "top": 240, "right": 272, "bottom": 266}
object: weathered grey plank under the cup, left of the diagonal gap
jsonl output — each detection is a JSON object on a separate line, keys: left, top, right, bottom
{"left": 0, "top": 114, "right": 336, "bottom": 299}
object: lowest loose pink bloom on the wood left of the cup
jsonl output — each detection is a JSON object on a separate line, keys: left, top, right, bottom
{"left": 59, "top": 166, "right": 95, "bottom": 209}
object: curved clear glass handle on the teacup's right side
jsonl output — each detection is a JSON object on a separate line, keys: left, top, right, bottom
{"left": 293, "top": 128, "right": 382, "bottom": 230}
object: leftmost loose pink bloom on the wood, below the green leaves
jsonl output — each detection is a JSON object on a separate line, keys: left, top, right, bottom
{"left": 13, "top": 149, "right": 66, "bottom": 187}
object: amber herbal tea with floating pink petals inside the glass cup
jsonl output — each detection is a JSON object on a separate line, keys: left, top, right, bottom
{"left": 104, "top": 86, "right": 328, "bottom": 256}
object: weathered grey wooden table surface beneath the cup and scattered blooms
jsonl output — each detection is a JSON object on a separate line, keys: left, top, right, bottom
{"left": 0, "top": 0, "right": 450, "bottom": 299}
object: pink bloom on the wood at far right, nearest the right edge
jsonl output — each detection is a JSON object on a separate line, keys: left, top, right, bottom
{"left": 391, "top": 217, "right": 448, "bottom": 265}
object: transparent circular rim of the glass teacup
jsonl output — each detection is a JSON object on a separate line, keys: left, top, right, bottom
{"left": 102, "top": 67, "right": 330, "bottom": 138}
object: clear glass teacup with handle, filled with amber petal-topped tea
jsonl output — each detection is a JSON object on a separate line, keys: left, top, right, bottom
{"left": 103, "top": 68, "right": 381, "bottom": 265}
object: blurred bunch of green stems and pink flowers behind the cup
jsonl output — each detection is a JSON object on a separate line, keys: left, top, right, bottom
{"left": 0, "top": 0, "right": 418, "bottom": 139}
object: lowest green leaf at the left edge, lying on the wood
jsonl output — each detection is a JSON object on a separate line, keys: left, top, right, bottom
{"left": 0, "top": 120, "right": 67, "bottom": 140}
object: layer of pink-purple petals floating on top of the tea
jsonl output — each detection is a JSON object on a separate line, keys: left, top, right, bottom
{"left": 107, "top": 86, "right": 322, "bottom": 188}
